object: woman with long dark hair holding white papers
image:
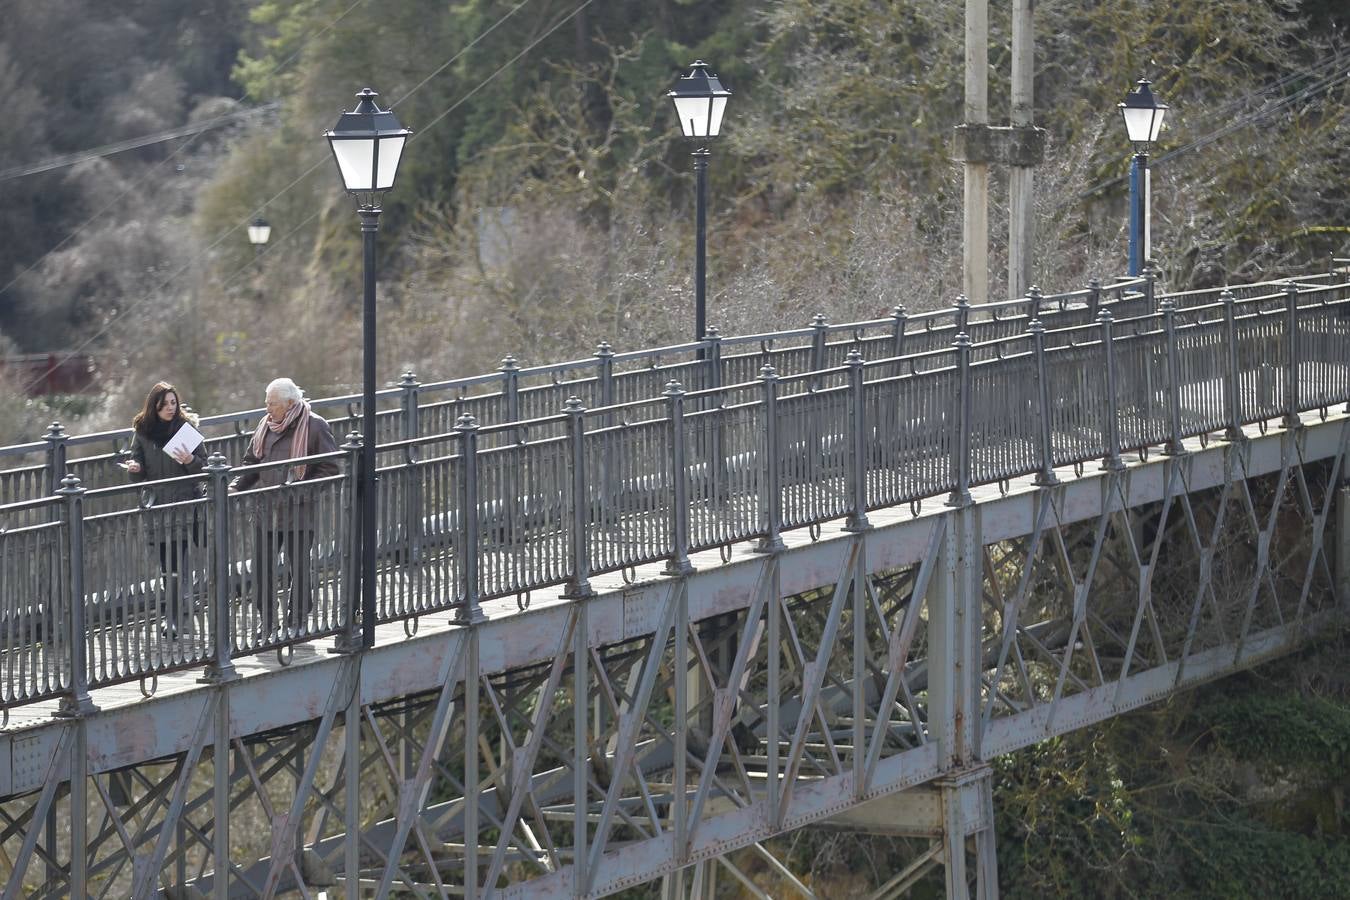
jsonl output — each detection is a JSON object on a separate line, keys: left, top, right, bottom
{"left": 123, "top": 382, "right": 207, "bottom": 637}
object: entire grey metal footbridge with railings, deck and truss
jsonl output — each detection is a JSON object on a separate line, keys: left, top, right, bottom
{"left": 0, "top": 277, "right": 1350, "bottom": 900}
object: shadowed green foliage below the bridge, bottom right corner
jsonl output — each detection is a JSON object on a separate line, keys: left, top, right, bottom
{"left": 995, "top": 636, "right": 1350, "bottom": 900}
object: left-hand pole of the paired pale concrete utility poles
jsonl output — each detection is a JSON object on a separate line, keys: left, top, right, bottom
{"left": 961, "top": 0, "right": 990, "bottom": 304}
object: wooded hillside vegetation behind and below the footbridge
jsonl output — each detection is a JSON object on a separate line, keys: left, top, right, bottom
{"left": 0, "top": 0, "right": 1350, "bottom": 897}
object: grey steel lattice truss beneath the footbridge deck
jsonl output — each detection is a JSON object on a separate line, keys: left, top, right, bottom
{"left": 0, "top": 417, "right": 1350, "bottom": 900}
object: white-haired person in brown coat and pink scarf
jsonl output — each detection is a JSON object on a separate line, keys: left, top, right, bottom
{"left": 231, "top": 378, "right": 338, "bottom": 641}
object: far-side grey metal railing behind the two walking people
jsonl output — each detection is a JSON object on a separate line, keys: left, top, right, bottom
{"left": 0, "top": 278, "right": 1153, "bottom": 503}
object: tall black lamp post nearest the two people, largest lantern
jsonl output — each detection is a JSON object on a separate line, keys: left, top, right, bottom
{"left": 324, "top": 88, "right": 412, "bottom": 649}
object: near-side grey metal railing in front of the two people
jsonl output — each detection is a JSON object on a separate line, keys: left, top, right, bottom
{"left": 0, "top": 277, "right": 1350, "bottom": 710}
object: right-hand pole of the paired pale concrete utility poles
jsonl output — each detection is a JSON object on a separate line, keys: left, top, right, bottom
{"left": 1008, "top": 0, "right": 1035, "bottom": 297}
